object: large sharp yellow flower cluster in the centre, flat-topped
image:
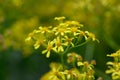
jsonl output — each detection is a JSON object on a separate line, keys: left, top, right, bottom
{"left": 26, "top": 17, "right": 97, "bottom": 58}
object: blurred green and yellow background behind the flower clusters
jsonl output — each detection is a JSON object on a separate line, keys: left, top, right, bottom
{"left": 0, "top": 0, "right": 120, "bottom": 80}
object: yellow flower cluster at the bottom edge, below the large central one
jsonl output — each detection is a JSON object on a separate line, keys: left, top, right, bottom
{"left": 41, "top": 52, "right": 96, "bottom": 80}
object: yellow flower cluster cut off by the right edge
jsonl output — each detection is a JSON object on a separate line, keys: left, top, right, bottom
{"left": 106, "top": 50, "right": 120, "bottom": 80}
